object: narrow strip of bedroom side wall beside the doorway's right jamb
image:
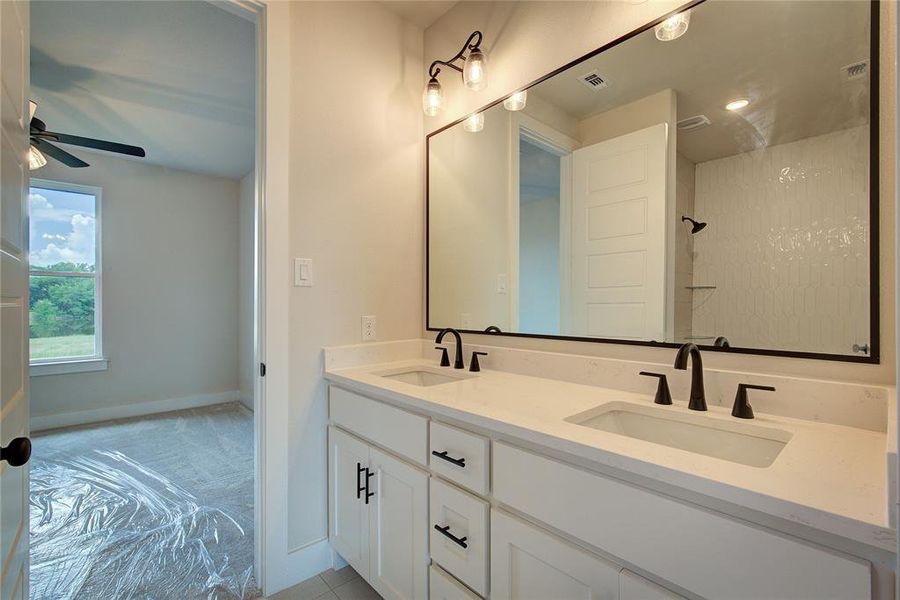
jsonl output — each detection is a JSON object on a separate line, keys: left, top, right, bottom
{"left": 237, "top": 172, "right": 256, "bottom": 410}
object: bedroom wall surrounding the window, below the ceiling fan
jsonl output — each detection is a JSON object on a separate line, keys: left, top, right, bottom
{"left": 31, "top": 150, "right": 238, "bottom": 417}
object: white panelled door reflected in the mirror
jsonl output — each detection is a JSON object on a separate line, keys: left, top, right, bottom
{"left": 566, "top": 123, "right": 667, "bottom": 341}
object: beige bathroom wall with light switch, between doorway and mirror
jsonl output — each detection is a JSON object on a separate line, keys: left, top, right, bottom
{"left": 284, "top": 2, "right": 424, "bottom": 552}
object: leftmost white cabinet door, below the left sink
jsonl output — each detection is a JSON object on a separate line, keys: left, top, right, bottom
{"left": 328, "top": 427, "right": 374, "bottom": 579}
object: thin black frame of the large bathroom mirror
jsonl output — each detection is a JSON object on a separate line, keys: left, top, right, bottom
{"left": 425, "top": 0, "right": 881, "bottom": 364}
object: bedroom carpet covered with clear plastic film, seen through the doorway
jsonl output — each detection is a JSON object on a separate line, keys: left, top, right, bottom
{"left": 31, "top": 403, "right": 259, "bottom": 600}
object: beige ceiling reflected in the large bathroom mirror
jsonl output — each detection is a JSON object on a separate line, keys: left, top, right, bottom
{"left": 529, "top": 0, "right": 869, "bottom": 162}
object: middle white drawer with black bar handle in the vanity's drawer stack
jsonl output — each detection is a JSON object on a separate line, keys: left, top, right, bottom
{"left": 429, "top": 477, "right": 489, "bottom": 596}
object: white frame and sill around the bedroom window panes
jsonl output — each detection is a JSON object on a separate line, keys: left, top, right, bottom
{"left": 28, "top": 177, "right": 107, "bottom": 375}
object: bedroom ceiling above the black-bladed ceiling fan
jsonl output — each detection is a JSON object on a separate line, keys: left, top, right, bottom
{"left": 31, "top": 0, "right": 255, "bottom": 179}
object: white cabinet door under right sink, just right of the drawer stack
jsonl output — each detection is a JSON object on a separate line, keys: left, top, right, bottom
{"left": 491, "top": 510, "right": 620, "bottom": 600}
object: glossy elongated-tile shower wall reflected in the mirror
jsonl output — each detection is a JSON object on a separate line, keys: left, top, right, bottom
{"left": 692, "top": 127, "right": 869, "bottom": 354}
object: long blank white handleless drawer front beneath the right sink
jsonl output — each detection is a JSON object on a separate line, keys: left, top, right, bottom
{"left": 492, "top": 442, "right": 872, "bottom": 600}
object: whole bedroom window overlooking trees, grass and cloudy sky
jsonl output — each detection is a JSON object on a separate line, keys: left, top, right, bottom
{"left": 29, "top": 179, "right": 106, "bottom": 375}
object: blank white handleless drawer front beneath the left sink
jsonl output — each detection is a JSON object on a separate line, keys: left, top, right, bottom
{"left": 328, "top": 386, "right": 428, "bottom": 465}
